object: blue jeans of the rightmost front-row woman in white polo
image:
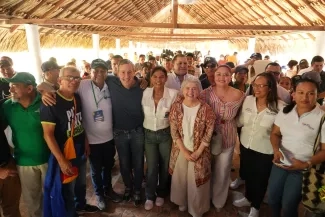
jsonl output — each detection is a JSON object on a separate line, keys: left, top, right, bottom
{"left": 268, "top": 165, "right": 302, "bottom": 217}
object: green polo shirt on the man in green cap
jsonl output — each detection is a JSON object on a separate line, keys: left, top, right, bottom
{"left": 0, "top": 93, "right": 50, "bottom": 166}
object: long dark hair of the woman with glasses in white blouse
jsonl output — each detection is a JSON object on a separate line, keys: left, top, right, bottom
{"left": 252, "top": 72, "right": 279, "bottom": 113}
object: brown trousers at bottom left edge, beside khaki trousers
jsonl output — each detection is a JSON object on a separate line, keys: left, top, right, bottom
{"left": 0, "top": 160, "right": 21, "bottom": 217}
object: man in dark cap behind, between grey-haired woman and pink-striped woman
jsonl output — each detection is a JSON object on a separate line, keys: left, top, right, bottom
{"left": 200, "top": 57, "right": 218, "bottom": 89}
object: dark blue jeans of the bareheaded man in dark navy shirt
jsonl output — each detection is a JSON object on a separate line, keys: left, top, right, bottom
{"left": 114, "top": 127, "right": 144, "bottom": 193}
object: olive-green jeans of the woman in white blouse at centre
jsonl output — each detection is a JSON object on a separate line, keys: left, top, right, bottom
{"left": 145, "top": 127, "right": 172, "bottom": 200}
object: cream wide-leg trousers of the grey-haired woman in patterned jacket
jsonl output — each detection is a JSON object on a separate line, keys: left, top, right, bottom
{"left": 170, "top": 152, "right": 210, "bottom": 217}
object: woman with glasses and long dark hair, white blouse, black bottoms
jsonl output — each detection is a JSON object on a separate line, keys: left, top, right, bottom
{"left": 233, "top": 73, "right": 284, "bottom": 217}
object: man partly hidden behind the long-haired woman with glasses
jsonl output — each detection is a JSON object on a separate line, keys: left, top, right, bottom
{"left": 246, "top": 62, "right": 291, "bottom": 104}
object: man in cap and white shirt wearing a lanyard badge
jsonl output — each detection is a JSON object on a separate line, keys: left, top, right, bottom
{"left": 77, "top": 59, "right": 122, "bottom": 210}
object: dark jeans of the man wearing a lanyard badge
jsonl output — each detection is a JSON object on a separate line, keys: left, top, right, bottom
{"left": 89, "top": 140, "right": 116, "bottom": 196}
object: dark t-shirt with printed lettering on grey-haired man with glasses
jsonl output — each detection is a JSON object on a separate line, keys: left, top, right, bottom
{"left": 41, "top": 92, "right": 85, "bottom": 164}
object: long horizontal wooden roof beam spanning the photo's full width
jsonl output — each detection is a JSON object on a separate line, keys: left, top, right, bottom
{"left": 5, "top": 18, "right": 325, "bottom": 31}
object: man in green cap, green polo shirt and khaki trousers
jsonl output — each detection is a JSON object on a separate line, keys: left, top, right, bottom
{"left": 1, "top": 72, "right": 49, "bottom": 217}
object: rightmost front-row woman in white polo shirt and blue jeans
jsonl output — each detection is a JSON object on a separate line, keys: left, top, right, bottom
{"left": 268, "top": 78, "right": 325, "bottom": 217}
